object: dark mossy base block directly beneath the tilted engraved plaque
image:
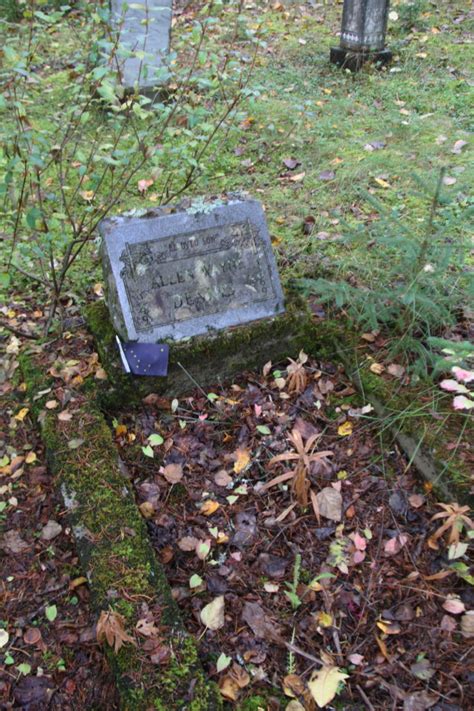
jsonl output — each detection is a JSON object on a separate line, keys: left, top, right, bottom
{"left": 86, "top": 298, "right": 318, "bottom": 408}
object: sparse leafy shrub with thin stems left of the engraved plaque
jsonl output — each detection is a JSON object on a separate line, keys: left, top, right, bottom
{"left": 0, "top": 0, "right": 259, "bottom": 330}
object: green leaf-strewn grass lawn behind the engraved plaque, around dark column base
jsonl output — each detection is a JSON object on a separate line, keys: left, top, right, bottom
{"left": 1, "top": 0, "right": 474, "bottom": 304}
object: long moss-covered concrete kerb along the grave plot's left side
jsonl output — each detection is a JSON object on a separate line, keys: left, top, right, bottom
{"left": 22, "top": 358, "right": 222, "bottom": 711}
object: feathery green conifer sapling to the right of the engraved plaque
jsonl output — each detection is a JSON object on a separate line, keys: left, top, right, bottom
{"left": 297, "top": 175, "right": 474, "bottom": 371}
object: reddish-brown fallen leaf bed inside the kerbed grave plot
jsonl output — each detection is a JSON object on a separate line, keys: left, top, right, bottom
{"left": 115, "top": 358, "right": 474, "bottom": 710}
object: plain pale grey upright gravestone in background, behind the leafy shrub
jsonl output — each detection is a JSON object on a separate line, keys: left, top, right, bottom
{"left": 111, "top": 0, "right": 172, "bottom": 91}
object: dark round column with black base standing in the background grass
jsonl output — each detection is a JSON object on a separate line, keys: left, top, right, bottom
{"left": 330, "top": 0, "right": 392, "bottom": 71}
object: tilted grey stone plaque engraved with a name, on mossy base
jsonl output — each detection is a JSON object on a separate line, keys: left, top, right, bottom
{"left": 99, "top": 198, "right": 284, "bottom": 343}
